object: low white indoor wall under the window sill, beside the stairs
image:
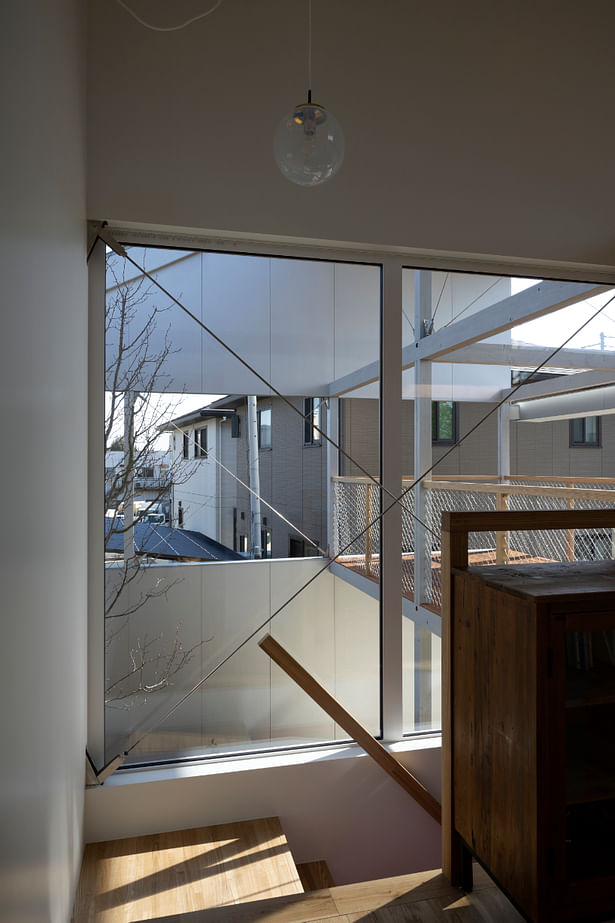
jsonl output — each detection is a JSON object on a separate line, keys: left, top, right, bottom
{"left": 86, "top": 739, "right": 441, "bottom": 884}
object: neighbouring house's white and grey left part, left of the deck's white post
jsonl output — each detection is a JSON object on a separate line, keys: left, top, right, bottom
{"left": 164, "top": 395, "right": 327, "bottom": 558}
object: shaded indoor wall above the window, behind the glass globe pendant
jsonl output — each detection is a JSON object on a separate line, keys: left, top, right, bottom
{"left": 89, "top": 0, "right": 615, "bottom": 265}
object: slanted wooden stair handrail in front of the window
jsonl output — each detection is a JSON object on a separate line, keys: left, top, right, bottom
{"left": 258, "top": 635, "right": 442, "bottom": 823}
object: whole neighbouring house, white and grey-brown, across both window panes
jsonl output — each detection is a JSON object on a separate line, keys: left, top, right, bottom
{"left": 165, "top": 396, "right": 615, "bottom": 557}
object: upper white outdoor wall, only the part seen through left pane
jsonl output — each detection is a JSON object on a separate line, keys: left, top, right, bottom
{"left": 107, "top": 247, "right": 380, "bottom": 396}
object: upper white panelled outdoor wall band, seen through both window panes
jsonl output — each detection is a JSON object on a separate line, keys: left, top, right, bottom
{"left": 107, "top": 247, "right": 510, "bottom": 401}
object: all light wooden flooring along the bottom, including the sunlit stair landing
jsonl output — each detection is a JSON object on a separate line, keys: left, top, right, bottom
{"left": 73, "top": 818, "right": 522, "bottom": 923}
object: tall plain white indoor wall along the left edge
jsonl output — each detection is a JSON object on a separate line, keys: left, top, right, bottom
{"left": 0, "top": 0, "right": 87, "bottom": 923}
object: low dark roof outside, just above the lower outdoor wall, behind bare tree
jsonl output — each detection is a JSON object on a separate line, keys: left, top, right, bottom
{"left": 105, "top": 516, "right": 244, "bottom": 561}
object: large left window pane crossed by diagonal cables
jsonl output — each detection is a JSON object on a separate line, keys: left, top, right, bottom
{"left": 105, "top": 248, "right": 380, "bottom": 763}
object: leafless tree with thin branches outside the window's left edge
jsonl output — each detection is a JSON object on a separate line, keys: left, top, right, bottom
{"left": 105, "top": 255, "right": 203, "bottom": 707}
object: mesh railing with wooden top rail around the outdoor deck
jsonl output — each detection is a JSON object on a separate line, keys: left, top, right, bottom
{"left": 333, "top": 477, "right": 615, "bottom": 607}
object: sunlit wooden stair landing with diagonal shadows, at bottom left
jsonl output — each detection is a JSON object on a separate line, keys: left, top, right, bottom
{"left": 73, "top": 817, "right": 303, "bottom": 923}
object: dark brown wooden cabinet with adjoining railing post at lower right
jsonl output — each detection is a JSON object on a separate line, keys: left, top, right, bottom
{"left": 442, "top": 512, "right": 615, "bottom": 923}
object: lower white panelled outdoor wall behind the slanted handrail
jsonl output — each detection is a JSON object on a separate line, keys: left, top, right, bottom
{"left": 106, "top": 558, "right": 380, "bottom": 761}
